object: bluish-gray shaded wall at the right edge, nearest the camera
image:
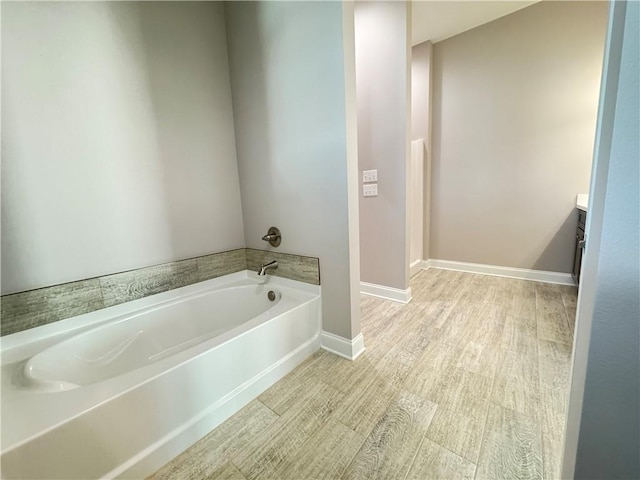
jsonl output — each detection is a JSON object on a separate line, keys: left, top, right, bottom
{"left": 575, "top": 1, "right": 640, "bottom": 479}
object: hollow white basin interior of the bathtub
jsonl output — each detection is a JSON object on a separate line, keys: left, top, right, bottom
{"left": 22, "top": 284, "right": 284, "bottom": 391}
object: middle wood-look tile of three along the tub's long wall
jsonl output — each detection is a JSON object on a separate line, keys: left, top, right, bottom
{"left": 100, "top": 259, "right": 198, "bottom": 307}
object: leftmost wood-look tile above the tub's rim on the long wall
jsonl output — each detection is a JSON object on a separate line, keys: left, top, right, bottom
{"left": 0, "top": 278, "right": 105, "bottom": 335}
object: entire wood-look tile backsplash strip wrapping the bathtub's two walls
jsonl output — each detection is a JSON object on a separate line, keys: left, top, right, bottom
{"left": 0, "top": 248, "right": 320, "bottom": 336}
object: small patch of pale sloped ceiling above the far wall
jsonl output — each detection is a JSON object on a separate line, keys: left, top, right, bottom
{"left": 411, "top": 0, "right": 539, "bottom": 45}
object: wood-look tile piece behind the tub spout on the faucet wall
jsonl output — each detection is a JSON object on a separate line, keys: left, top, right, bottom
{"left": 247, "top": 248, "right": 320, "bottom": 285}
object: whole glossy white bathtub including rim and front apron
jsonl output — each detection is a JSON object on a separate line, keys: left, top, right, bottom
{"left": 0, "top": 271, "right": 321, "bottom": 479}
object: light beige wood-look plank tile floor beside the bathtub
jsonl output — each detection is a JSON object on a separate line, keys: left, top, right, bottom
{"left": 150, "top": 269, "right": 577, "bottom": 480}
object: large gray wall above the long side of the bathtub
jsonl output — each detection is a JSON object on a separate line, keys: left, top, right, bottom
{"left": 2, "top": 2, "right": 244, "bottom": 293}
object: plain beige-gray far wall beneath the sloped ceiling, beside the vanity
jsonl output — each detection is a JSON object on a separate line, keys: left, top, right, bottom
{"left": 431, "top": 1, "right": 607, "bottom": 272}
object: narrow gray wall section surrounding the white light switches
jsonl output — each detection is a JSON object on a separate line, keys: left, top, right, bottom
{"left": 355, "top": 1, "right": 411, "bottom": 290}
